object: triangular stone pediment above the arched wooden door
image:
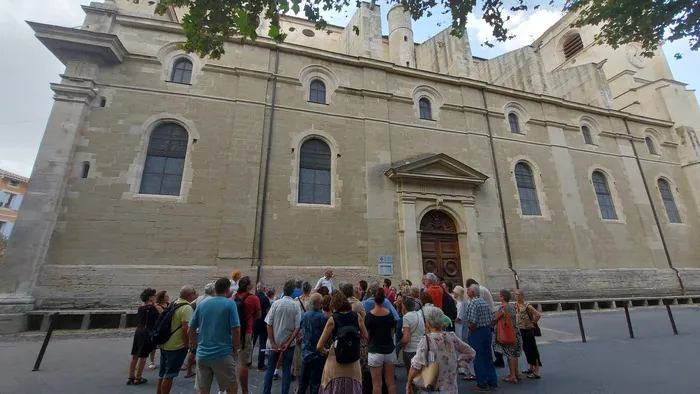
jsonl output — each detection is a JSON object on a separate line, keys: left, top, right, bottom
{"left": 384, "top": 153, "right": 488, "bottom": 185}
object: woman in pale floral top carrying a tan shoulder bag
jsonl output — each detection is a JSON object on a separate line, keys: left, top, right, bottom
{"left": 406, "top": 305, "right": 476, "bottom": 394}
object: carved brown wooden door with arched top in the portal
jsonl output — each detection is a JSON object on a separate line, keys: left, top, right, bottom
{"left": 420, "top": 210, "right": 464, "bottom": 285}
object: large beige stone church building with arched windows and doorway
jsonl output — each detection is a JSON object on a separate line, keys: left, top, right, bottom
{"left": 0, "top": 0, "right": 700, "bottom": 322}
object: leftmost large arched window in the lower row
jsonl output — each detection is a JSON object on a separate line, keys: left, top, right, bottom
{"left": 139, "top": 123, "right": 188, "bottom": 196}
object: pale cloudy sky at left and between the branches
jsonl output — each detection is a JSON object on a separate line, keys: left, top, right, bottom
{"left": 0, "top": 0, "right": 700, "bottom": 176}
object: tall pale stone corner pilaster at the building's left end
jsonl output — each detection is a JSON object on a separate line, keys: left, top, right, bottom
{"left": 0, "top": 62, "right": 97, "bottom": 313}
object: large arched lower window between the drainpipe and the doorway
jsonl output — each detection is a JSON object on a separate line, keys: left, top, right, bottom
{"left": 299, "top": 138, "right": 331, "bottom": 205}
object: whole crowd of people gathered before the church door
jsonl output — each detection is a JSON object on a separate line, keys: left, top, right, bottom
{"left": 127, "top": 269, "right": 542, "bottom": 394}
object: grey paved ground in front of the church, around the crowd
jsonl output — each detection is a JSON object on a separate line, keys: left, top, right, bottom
{"left": 0, "top": 306, "right": 700, "bottom": 394}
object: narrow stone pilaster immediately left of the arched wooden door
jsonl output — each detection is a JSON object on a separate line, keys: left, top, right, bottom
{"left": 399, "top": 196, "right": 423, "bottom": 283}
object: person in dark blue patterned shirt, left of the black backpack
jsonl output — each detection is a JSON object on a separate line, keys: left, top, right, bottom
{"left": 298, "top": 293, "right": 328, "bottom": 394}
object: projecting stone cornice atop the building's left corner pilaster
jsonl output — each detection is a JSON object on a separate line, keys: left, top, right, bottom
{"left": 27, "top": 21, "right": 129, "bottom": 65}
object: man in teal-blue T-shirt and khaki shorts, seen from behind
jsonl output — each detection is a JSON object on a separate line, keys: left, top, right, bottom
{"left": 187, "top": 278, "right": 241, "bottom": 394}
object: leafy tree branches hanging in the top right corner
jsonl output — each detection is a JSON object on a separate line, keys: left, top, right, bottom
{"left": 564, "top": 0, "right": 700, "bottom": 57}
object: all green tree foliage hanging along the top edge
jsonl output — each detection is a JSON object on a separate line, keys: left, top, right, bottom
{"left": 156, "top": 0, "right": 700, "bottom": 58}
